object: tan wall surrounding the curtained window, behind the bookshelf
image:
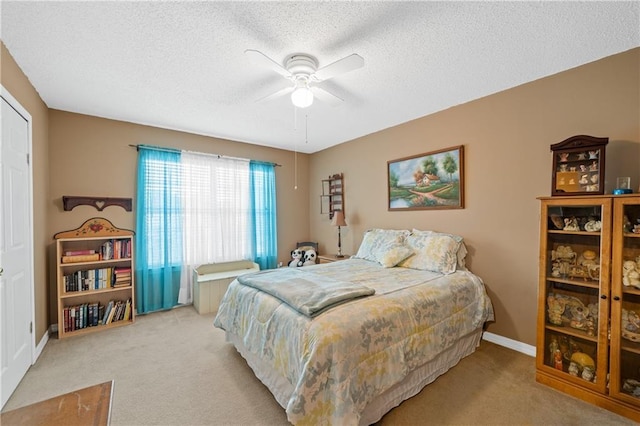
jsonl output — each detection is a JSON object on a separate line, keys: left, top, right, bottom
{"left": 49, "top": 110, "right": 309, "bottom": 322}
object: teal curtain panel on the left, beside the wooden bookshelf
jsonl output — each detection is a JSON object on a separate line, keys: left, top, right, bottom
{"left": 135, "top": 145, "right": 184, "bottom": 314}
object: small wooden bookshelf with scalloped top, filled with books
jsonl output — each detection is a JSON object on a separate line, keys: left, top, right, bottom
{"left": 54, "top": 218, "right": 135, "bottom": 339}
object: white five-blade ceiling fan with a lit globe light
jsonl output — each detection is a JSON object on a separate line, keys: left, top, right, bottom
{"left": 244, "top": 49, "right": 364, "bottom": 108}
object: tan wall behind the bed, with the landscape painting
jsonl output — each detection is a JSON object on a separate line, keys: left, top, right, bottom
{"left": 309, "top": 49, "right": 640, "bottom": 345}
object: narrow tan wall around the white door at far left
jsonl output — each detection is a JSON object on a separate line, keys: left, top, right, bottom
{"left": 0, "top": 42, "right": 50, "bottom": 343}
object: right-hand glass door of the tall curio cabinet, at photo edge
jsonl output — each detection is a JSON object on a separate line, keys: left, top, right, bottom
{"left": 609, "top": 196, "right": 640, "bottom": 406}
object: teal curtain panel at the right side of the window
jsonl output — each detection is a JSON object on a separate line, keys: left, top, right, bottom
{"left": 249, "top": 161, "right": 278, "bottom": 269}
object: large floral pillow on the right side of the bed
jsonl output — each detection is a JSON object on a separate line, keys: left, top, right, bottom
{"left": 398, "top": 231, "right": 466, "bottom": 274}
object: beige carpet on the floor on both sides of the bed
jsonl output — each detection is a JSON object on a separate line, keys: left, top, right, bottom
{"left": 3, "top": 307, "right": 635, "bottom": 426}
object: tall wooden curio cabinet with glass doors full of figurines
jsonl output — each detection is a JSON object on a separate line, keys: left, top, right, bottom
{"left": 536, "top": 196, "right": 640, "bottom": 421}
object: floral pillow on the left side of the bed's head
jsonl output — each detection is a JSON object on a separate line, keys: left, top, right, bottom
{"left": 354, "top": 229, "right": 413, "bottom": 268}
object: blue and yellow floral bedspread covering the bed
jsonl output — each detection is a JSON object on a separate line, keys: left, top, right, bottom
{"left": 214, "top": 259, "right": 493, "bottom": 425}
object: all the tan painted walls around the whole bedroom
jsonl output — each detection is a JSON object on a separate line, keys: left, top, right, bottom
{"left": 0, "top": 35, "right": 640, "bottom": 345}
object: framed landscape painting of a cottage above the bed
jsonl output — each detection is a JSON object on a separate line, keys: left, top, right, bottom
{"left": 387, "top": 145, "right": 464, "bottom": 211}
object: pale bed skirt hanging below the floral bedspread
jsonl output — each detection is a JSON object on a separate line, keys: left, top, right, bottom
{"left": 225, "top": 328, "right": 482, "bottom": 425}
